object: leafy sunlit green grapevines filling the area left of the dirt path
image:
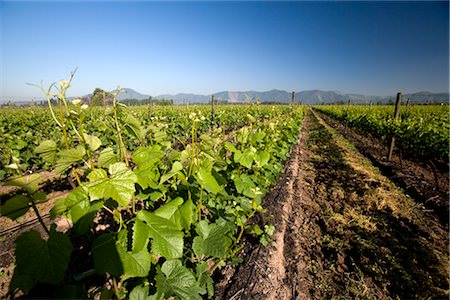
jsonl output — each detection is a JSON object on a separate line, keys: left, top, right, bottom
{"left": 0, "top": 74, "right": 304, "bottom": 299}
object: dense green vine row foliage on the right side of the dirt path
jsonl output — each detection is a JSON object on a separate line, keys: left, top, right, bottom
{"left": 316, "top": 105, "right": 450, "bottom": 161}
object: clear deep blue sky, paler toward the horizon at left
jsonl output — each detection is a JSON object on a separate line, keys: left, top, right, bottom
{"left": 0, "top": 0, "right": 449, "bottom": 100}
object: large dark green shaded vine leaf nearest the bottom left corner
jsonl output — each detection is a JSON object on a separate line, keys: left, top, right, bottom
{"left": 14, "top": 226, "right": 73, "bottom": 288}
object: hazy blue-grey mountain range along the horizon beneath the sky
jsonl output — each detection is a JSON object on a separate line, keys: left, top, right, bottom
{"left": 118, "top": 88, "right": 449, "bottom": 104}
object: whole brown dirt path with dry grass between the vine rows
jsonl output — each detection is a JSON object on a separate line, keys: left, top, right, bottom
{"left": 216, "top": 111, "right": 449, "bottom": 299}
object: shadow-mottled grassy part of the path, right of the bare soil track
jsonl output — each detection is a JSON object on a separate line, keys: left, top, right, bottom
{"left": 308, "top": 111, "right": 449, "bottom": 298}
